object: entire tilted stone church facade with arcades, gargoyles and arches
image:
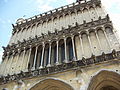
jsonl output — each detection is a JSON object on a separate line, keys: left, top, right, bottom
{"left": 0, "top": 0, "right": 120, "bottom": 90}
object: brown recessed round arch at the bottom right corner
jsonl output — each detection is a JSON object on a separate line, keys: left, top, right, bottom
{"left": 88, "top": 71, "right": 120, "bottom": 90}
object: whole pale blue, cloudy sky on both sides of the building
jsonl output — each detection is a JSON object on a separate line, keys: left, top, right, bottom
{"left": 0, "top": 0, "right": 120, "bottom": 62}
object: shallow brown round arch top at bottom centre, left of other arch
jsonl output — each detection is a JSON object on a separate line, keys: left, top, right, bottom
{"left": 30, "top": 79, "right": 74, "bottom": 90}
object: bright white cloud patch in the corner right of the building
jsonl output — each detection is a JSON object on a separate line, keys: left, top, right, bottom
{"left": 102, "top": 0, "right": 120, "bottom": 30}
